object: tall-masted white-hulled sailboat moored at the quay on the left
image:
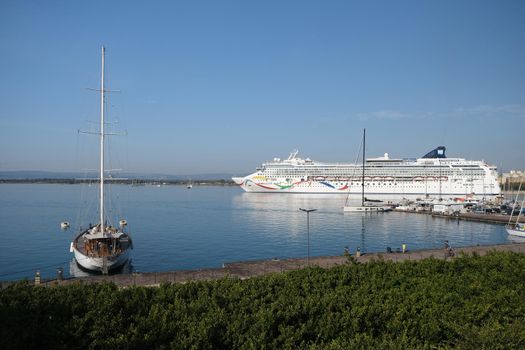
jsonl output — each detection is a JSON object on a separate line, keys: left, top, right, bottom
{"left": 70, "top": 47, "right": 133, "bottom": 274}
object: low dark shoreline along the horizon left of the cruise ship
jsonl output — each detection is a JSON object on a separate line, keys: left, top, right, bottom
{"left": 0, "top": 178, "right": 235, "bottom": 186}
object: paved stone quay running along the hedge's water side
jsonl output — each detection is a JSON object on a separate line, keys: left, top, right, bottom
{"left": 13, "top": 243, "right": 525, "bottom": 288}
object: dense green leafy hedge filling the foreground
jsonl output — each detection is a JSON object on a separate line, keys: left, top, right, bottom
{"left": 0, "top": 252, "right": 525, "bottom": 349}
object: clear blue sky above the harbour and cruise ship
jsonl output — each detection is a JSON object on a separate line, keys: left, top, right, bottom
{"left": 0, "top": 0, "right": 525, "bottom": 175}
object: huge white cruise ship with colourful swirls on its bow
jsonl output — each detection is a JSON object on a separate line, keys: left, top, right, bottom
{"left": 233, "top": 146, "right": 500, "bottom": 197}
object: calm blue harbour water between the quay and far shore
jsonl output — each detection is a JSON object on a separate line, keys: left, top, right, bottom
{"left": 0, "top": 184, "right": 508, "bottom": 280}
